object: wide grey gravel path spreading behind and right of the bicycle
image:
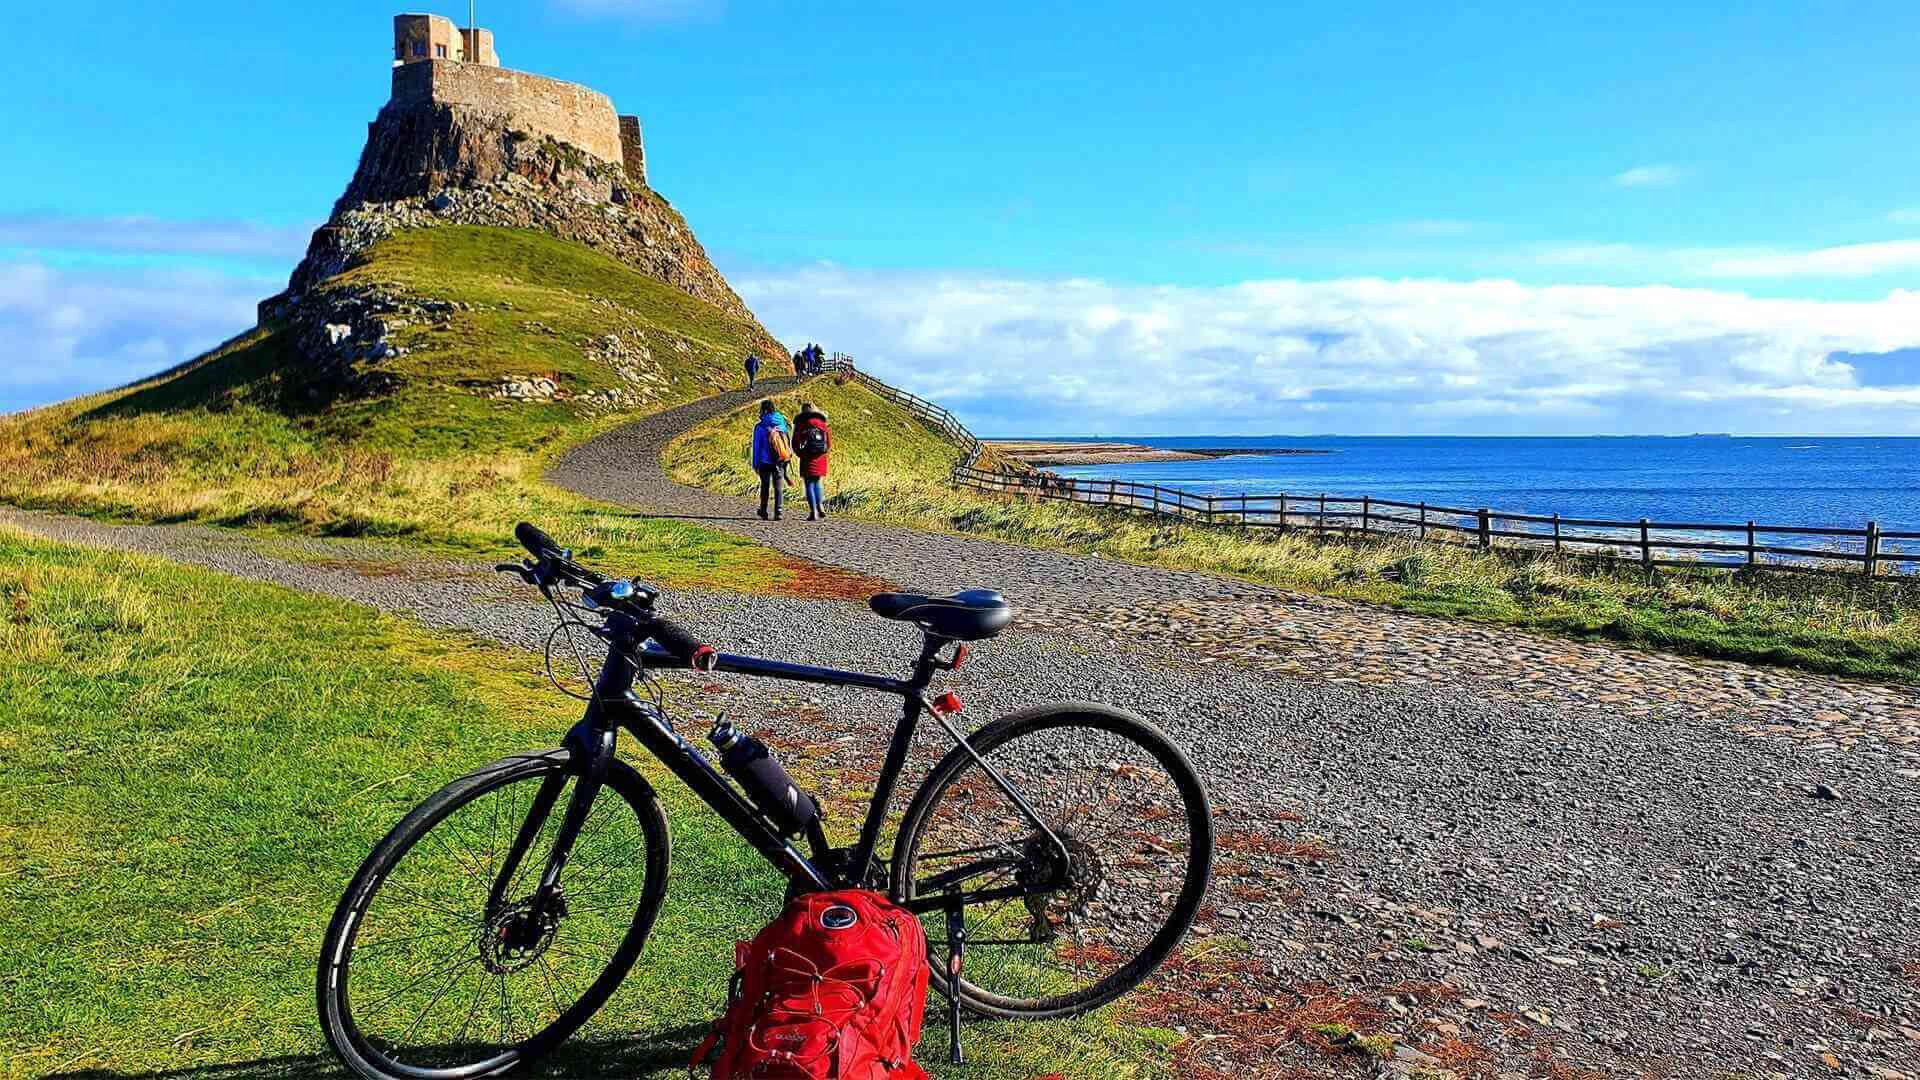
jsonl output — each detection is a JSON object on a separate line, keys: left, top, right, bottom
{"left": 0, "top": 413, "right": 1920, "bottom": 1078}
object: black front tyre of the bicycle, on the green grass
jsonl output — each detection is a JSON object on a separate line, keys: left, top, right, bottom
{"left": 315, "top": 749, "right": 672, "bottom": 1080}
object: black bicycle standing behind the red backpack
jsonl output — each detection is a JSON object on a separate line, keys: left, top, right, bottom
{"left": 319, "top": 523, "right": 1213, "bottom": 1080}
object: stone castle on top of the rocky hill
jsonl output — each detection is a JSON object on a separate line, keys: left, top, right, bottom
{"left": 392, "top": 13, "right": 647, "bottom": 184}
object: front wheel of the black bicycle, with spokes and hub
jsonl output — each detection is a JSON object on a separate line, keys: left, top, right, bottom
{"left": 317, "top": 749, "right": 668, "bottom": 1080}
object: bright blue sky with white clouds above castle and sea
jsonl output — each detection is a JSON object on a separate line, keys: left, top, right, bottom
{"left": 0, "top": 0, "right": 1920, "bottom": 434}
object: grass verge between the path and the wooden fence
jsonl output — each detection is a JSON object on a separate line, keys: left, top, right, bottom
{"left": 668, "top": 379, "right": 1920, "bottom": 682}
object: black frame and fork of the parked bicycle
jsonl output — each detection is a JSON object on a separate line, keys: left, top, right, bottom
{"left": 503, "top": 613, "right": 1068, "bottom": 913}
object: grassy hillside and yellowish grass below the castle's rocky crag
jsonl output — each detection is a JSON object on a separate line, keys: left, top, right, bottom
{"left": 0, "top": 227, "right": 825, "bottom": 588}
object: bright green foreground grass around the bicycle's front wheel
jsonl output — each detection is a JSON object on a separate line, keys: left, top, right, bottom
{"left": 0, "top": 530, "right": 1164, "bottom": 1080}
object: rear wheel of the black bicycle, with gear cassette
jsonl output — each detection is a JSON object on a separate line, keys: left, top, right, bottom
{"left": 893, "top": 703, "right": 1213, "bottom": 1020}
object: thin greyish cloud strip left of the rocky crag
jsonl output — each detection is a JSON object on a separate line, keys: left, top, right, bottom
{"left": 0, "top": 213, "right": 313, "bottom": 261}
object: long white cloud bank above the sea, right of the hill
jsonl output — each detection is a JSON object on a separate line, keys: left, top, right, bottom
{"left": 735, "top": 267, "right": 1920, "bottom": 434}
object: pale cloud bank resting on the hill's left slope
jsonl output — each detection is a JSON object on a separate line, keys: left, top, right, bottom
{"left": 0, "top": 261, "right": 284, "bottom": 411}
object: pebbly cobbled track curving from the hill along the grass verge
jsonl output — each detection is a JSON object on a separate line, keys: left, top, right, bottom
{"left": 551, "top": 379, "right": 1920, "bottom": 749}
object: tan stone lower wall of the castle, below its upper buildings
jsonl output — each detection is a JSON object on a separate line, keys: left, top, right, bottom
{"left": 394, "top": 60, "right": 622, "bottom": 165}
